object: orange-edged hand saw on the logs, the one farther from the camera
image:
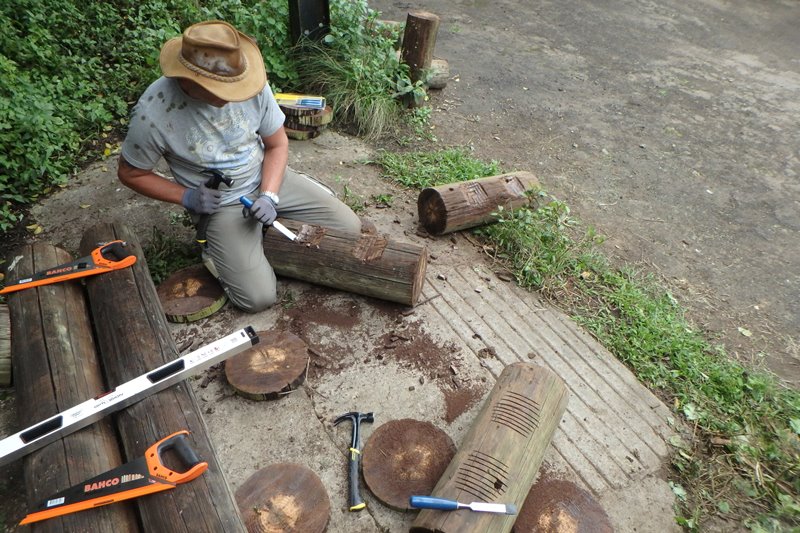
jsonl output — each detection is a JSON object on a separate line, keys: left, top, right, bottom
{"left": 0, "top": 241, "right": 136, "bottom": 294}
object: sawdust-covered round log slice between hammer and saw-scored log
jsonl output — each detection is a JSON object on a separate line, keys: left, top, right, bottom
{"left": 362, "top": 418, "right": 456, "bottom": 511}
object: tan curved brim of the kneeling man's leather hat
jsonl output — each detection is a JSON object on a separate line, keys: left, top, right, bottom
{"left": 159, "top": 32, "right": 267, "bottom": 102}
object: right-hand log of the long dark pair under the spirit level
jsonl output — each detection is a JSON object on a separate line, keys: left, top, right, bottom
{"left": 81, "top": 222, "right": 245, "bottom": 533}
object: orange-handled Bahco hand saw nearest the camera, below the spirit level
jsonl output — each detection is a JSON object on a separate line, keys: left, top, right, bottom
{"left": 20, "top": 429, "right": 208, "bottom": 525}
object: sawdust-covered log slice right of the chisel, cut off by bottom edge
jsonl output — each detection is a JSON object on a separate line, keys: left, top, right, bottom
{"left": 512, "top": 479, "right": 614, "bottom": 533}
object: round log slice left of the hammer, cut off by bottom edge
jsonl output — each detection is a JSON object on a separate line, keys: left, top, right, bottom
{"left": 236, "top": 464, "right": 331, "bottom": 533}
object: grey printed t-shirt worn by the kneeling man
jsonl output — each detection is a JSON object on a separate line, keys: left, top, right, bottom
{"left": 122, "top": 77, "right": 285, "bottom": 205}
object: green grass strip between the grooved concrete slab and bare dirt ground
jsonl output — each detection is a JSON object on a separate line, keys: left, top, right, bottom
{"left": 377, "top": 149, "right": 800, "bottom": 531}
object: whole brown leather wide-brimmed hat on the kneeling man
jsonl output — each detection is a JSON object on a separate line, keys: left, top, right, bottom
{"left": 160, "top": 20, "right": 267, "bottom": 102}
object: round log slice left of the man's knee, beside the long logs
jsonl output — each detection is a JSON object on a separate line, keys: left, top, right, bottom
{"left": 156, "top": 264, "right": 228, "bottom": 323}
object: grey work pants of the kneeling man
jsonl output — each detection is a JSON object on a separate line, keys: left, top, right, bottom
{"left": 203, "top": 168, "right": 361, "bottom": 313}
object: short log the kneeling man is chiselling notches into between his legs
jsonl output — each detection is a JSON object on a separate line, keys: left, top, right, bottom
{"left": 264, "top": 220, "right": 428, "bottom": 306}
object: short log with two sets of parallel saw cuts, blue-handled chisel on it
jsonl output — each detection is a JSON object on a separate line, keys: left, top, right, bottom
{"left": 409, "top": 363, "right": 569, "bottom": 533}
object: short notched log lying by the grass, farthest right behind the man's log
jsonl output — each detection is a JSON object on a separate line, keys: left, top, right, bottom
{"left": 417, "top": 172, "right": 539, "bottom": 235}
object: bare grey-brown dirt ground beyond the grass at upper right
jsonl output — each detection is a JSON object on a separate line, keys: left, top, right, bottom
{"left": 370, "top": 0, "right": 800, "bottom": 386}
